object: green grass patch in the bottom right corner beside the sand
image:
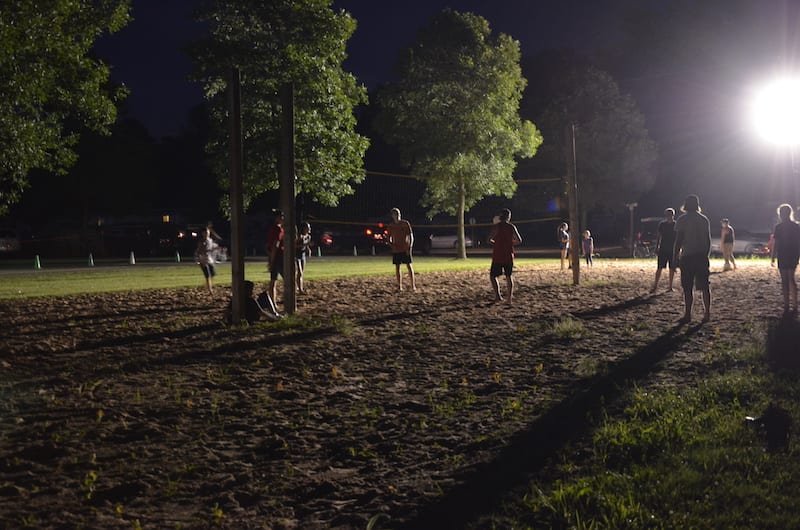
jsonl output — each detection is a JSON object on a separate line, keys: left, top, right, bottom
{"left": 496, "top": 322, "right": 800, "bottom": 529}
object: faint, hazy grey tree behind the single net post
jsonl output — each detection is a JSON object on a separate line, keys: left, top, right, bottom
{"left": 525, "top": 54, "right": 658, "bottom": 228}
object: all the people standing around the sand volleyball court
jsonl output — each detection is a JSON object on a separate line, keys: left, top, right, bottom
{"left": 212, "top": 195, "right": 800, "bottom": 324}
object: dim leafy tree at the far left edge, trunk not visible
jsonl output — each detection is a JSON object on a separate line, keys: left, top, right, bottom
{"left": 0, "top": 0, "right": 130, "bottom": 214}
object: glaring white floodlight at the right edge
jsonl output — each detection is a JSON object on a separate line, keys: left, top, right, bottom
{"left": 753, "top": 79, "right": 800, "bottom": 145}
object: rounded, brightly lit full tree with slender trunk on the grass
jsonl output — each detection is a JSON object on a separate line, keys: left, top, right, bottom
{"left": 377, "top": 9, "right": 542, "bottom": 258}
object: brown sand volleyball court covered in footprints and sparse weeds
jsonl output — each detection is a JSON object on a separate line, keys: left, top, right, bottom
{"left": 0, "top": 261, "right": 780, "bottom": 528}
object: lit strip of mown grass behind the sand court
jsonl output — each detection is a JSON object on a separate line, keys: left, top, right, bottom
{"left": 0, "top": 256, "right": 546, "bottom": 299}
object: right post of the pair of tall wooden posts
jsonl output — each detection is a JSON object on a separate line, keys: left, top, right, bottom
{"left": 278, "top": 83, "right": 297, "bottom": 315}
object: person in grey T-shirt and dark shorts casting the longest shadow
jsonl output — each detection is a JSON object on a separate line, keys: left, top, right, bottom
{"left": 673, "top": 195, "right": 711, "bottom": 324}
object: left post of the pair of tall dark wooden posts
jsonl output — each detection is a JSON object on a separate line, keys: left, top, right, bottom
{"left": 228, "top": 67, "right": 245, "bottom": 324}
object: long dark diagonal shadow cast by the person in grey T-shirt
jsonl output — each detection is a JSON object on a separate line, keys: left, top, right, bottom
{"left": 400, "top": 325, "right": 701, "bottom": 529}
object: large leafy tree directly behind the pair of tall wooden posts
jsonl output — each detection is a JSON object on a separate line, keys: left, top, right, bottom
{"left": 193, "top": 0, "right": 368, "bottom": 214}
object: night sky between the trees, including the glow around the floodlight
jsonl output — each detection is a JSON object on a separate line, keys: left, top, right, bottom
{"left": 98, "top": 0, "right": 800, "bottom": 228}
